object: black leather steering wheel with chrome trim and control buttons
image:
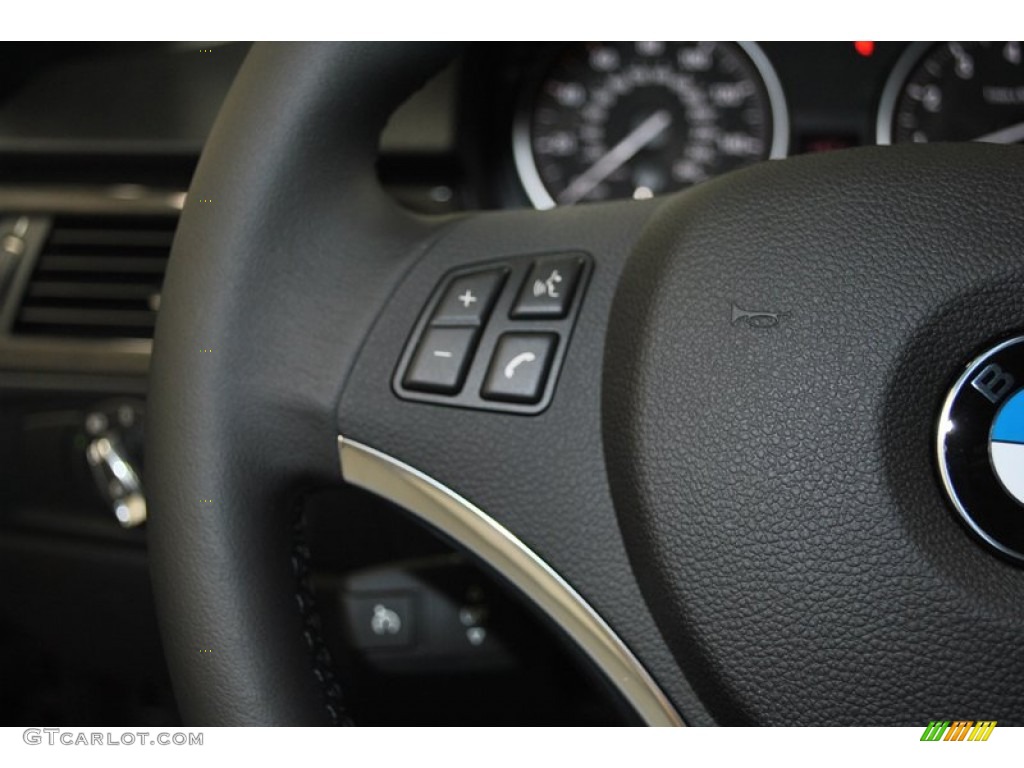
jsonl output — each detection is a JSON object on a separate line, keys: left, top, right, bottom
{"left": 146, "top": 44, "right": 1024, "bottom": 725}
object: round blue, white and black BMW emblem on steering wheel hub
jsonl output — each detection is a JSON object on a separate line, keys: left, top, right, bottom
{"left": 938, "top": 336, "right": 1024, "bottom": 562}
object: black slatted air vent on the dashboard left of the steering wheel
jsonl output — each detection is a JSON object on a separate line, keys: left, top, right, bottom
{"left": 14, "top": 216, "right": 177, "bottom": 339}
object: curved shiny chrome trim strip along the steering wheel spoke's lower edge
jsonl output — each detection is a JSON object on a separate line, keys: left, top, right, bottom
{"left": 338, "top": 436, "right": 685, "bottom": 726}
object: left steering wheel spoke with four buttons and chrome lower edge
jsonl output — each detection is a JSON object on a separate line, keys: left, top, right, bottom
{"left": 339, "top": 203, "right": 692, "bottom": 724}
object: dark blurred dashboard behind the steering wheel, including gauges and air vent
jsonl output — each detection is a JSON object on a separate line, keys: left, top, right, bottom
{"left": 0, "top": 41, "right": 1024, "bottom": 724}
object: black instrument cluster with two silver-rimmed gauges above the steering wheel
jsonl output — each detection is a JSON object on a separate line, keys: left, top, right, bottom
{"left": 461, "top": 41, "right": 1024, "bottom": 208}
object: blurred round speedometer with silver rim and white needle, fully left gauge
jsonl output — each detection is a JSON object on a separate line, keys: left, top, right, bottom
{"left": 513, "top": 42, "right": 788, "bottom": 208}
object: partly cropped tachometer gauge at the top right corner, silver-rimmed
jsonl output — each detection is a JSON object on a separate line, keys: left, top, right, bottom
{"left": 878, "top": 42, "right": 1024, "bottom": 144}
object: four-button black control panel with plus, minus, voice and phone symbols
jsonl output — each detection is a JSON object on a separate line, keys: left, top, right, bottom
{"left": 392, "top": 252, "right": 592, "bottom": 414}
